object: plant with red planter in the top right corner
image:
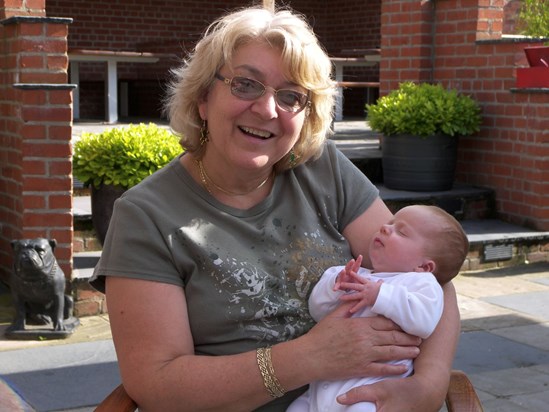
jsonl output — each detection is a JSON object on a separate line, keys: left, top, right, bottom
{"left": 517, "top": 0, "right": 549, "bottom": 87}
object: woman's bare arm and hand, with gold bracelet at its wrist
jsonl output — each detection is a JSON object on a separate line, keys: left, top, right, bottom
{"left": 106, "top": 277, "right": 419, "bottom": 411}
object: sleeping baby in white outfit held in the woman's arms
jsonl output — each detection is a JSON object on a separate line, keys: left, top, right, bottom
{"left": 287, "top": 205, "right": 469, "bottom": 412}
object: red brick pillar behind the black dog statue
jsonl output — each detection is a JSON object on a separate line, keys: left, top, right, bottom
{"left": 0, "top": 11, "right": 73, "bottom": 281}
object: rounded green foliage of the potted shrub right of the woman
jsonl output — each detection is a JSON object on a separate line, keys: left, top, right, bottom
{"left": 366, "top": 82, "right": 481, "bottom": 136}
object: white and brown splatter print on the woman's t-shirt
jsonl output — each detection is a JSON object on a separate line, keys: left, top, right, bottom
{"left": 177, "top": 218, "right": 343, "bottom": 343}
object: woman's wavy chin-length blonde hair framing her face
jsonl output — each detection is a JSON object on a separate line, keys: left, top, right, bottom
{"left": 166, "top": 7, "right": 335, "bottom": 171}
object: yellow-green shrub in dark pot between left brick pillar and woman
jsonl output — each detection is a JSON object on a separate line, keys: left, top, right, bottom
{"left": 73, "top": 123, "right": 182, "bottom": 244}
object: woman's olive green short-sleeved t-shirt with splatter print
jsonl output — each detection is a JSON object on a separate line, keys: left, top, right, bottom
{"left": 91, "top": 141, "right": 378, "bottom": 411}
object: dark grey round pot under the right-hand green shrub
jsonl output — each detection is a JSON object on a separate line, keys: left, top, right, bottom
{"left": 381, "top": 134, "right": 458, "bottom": 192}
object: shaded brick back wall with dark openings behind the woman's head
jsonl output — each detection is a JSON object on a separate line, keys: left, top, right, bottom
{"left": 47, "top": 0, "right": 381, "bottom": 118}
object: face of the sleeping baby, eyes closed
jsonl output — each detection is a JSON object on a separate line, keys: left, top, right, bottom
{"left": 369, "top": 206, "right": 437, "bottom": 272}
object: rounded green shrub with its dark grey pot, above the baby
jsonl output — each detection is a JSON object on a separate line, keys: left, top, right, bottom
{"left": 366, "top": 82, "right": 481, "bottom": 191}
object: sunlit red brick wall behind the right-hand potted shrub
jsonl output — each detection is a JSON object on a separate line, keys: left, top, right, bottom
{"left": 381, "top": 0, "right": 549, "bottom": 230}
